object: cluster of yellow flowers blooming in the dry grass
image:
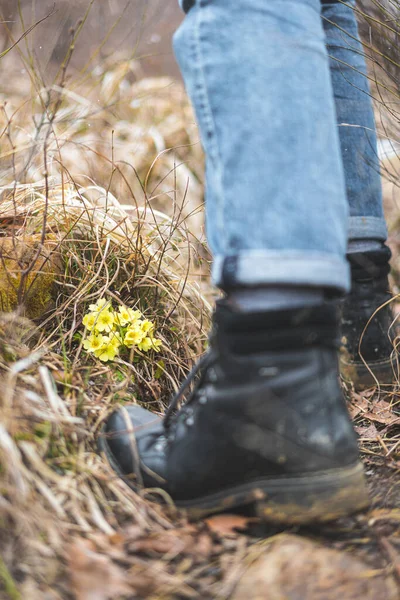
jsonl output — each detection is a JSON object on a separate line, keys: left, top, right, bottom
{"left": 82, "top": 298, "right": 161, "bottom": 362}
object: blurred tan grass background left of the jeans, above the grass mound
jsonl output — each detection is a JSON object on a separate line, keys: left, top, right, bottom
{"left": 0, "top": 0, "right": 204, "bottom": 250}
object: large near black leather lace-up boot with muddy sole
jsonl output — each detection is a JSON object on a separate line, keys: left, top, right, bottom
{"left": 100, "top": 302, "right": 367, "bottom": 523}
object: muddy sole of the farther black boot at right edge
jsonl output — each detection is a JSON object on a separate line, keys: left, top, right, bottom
{"left": 340, "top": 358, "right": 396, "bottom": 392}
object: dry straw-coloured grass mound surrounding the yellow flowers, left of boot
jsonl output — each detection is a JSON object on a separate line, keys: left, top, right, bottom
{"left": 0, "top": 143, "right": 209, "bottom": 599}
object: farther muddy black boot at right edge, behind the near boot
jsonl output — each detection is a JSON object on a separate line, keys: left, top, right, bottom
{"left": 340, "top": 246, "right": 395, "bottom": 390}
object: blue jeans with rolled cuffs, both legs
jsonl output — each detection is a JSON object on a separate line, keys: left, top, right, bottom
{"left": 174, "top": 0, "right": 387, "bottom": 292}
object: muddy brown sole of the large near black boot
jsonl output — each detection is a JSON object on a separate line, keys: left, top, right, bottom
{"left": 98, "top": 428, "right": 369, "bottom": 525}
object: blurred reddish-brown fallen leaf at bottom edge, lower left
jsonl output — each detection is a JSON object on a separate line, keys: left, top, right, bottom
{"left": 67, "top": 538, "right": 131, "bottom": 600}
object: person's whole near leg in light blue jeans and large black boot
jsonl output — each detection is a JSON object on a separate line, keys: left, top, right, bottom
{"left": 100, "top": 0, "right": 366, "bottom": 523}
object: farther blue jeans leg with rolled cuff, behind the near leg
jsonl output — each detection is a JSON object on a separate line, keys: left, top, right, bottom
{"left": 321, "top": 0, "right": 387, "bottom": 249}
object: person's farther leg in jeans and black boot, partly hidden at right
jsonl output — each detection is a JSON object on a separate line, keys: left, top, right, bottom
{"left": 321, "top": 0, "right": 393, "bottom": 387}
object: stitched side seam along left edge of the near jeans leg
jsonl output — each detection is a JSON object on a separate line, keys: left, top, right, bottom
{"left": 193, "top": 0, "right": 227, "bottom": 246}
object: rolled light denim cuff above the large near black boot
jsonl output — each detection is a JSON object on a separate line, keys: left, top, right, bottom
{"left": 212, "top": 250, "right": 350, "bottom": 293}
